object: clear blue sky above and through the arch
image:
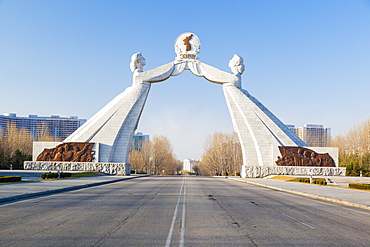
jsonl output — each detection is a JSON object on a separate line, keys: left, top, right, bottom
{"left": 0, "top": 0, "right": 370, "bottom": 159}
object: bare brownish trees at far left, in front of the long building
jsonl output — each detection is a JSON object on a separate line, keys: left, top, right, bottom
{"left": 0, "top": 123, "right": 58, "bottom": 169}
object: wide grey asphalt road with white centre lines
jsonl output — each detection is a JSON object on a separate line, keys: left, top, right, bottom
{"left": 0, "top": 176, "right": 370, "bottom": 246}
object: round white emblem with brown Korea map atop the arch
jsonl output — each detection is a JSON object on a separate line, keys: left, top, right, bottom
{"left": 175, "top": 33, "right": 200, "bottom": 60}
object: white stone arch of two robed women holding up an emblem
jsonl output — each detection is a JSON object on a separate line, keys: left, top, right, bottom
{"left": 26, "top": 32, "right": 344, "bottom": 177}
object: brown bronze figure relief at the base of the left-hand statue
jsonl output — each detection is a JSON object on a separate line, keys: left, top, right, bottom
{"left": 36, "top": 142, "right": 95, "bottom": 162}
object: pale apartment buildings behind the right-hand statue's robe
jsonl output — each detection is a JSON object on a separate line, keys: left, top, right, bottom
{"left": 286, "top": 124, "right": 331, "bottom": 147}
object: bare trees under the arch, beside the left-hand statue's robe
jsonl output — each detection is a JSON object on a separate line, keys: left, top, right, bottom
{"left": 129, "top": 136, "right": 182, "bottom": 175}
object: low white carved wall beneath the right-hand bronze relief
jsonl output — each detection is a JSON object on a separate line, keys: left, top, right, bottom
{"left": 240, "top": 166, "right": 346, "bottom": 178}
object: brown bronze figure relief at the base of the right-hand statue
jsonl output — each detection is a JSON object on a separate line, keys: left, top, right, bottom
{"left": 276, "top": 146, "right": 335, "bottom": 167}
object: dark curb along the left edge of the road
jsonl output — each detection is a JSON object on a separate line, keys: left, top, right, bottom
{"left": 0, "top": 176, "right": 145, "bottom": 203}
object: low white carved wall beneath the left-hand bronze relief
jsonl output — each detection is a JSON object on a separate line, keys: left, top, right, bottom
{"left": 23, "top": 161, "right": 130, "bottom": 176}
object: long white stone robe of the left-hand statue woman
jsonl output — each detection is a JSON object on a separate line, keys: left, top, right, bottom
{"left": 64, "top": 83, "right": 150, "bottom": 163}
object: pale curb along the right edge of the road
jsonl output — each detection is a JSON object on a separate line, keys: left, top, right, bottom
{"left": 229, "top": 178, "right": 370, "bottom": 210}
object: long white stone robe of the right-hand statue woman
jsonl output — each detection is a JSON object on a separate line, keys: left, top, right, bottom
{"left": 223, "top": 84, "right": 307, "bottom": 170}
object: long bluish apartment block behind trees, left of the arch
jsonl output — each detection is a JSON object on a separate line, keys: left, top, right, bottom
{"left": 0, "top": 113, "right": 86, "bottom": 141}
